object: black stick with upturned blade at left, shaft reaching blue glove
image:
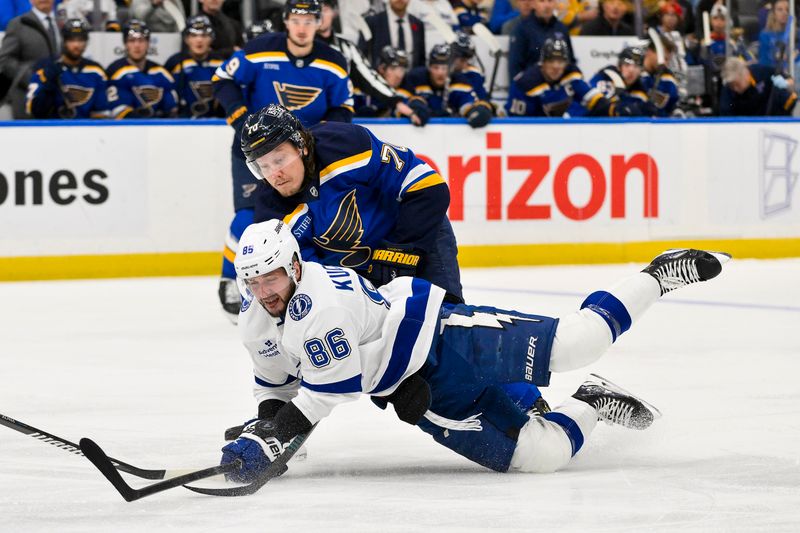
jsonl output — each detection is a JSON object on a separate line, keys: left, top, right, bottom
{"left": 80, "top": 438, "right": 242, "bottom": 502}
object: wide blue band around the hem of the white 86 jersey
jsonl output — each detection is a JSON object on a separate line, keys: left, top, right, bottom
{"left": 369, "top": 278, "right": 431, "bottom": 394}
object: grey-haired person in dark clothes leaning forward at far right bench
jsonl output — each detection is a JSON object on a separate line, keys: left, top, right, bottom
{"left": 719, "top": 57, "right": 797, "bottom": 117}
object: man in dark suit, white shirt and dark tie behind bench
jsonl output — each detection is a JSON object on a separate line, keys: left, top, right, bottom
{"left": 358, "top": 0, "right": 425, "bottom": 68}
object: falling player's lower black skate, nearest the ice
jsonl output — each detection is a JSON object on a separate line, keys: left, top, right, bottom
{"left": 572, "top": 374, "right": 661, "bottom": 429}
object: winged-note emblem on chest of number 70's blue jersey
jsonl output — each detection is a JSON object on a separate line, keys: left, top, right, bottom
{"left": 314, "top": 189, "right": 372, "bottom": 268}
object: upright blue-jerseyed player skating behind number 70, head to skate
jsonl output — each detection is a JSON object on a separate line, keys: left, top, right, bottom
{"left": 213, "top": 0, "right": 353, "bottom": 318}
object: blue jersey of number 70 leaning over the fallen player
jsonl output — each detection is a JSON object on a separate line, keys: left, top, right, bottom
{"left": 255, "top": 122, "right": 450, "bottom": 272}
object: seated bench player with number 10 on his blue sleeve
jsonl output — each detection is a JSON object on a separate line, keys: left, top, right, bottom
{"left": 506, "top": 39, "right": 614, "bottom": 117}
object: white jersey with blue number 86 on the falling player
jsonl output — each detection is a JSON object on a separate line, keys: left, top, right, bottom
{"left": 239, "top": 262, "right": 445, "bottom": 423}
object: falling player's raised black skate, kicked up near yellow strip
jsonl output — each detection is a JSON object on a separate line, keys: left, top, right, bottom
{"left": 642, "top": 248, "right": 731, "bottom": 296}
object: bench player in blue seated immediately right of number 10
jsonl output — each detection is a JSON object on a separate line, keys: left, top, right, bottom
{"left": 589, "top": 46, "right": 658, "bottom": 116}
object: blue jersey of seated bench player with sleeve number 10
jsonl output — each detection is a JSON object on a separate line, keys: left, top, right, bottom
{"left": 506, "top": 64, "right": 611, "bottom": 117}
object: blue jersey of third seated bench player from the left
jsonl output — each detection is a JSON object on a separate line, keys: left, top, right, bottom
{"left": 164, "top": 52, "right": 224, "bottom": 118}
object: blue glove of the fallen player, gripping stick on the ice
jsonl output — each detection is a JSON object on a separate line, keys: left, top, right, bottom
{"left": 220, "top": 419, "right": 288, "bottom": 483}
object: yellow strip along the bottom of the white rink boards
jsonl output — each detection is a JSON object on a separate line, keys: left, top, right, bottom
{"left": 0, "top": 238, "right": 800, "bottom": 281}
